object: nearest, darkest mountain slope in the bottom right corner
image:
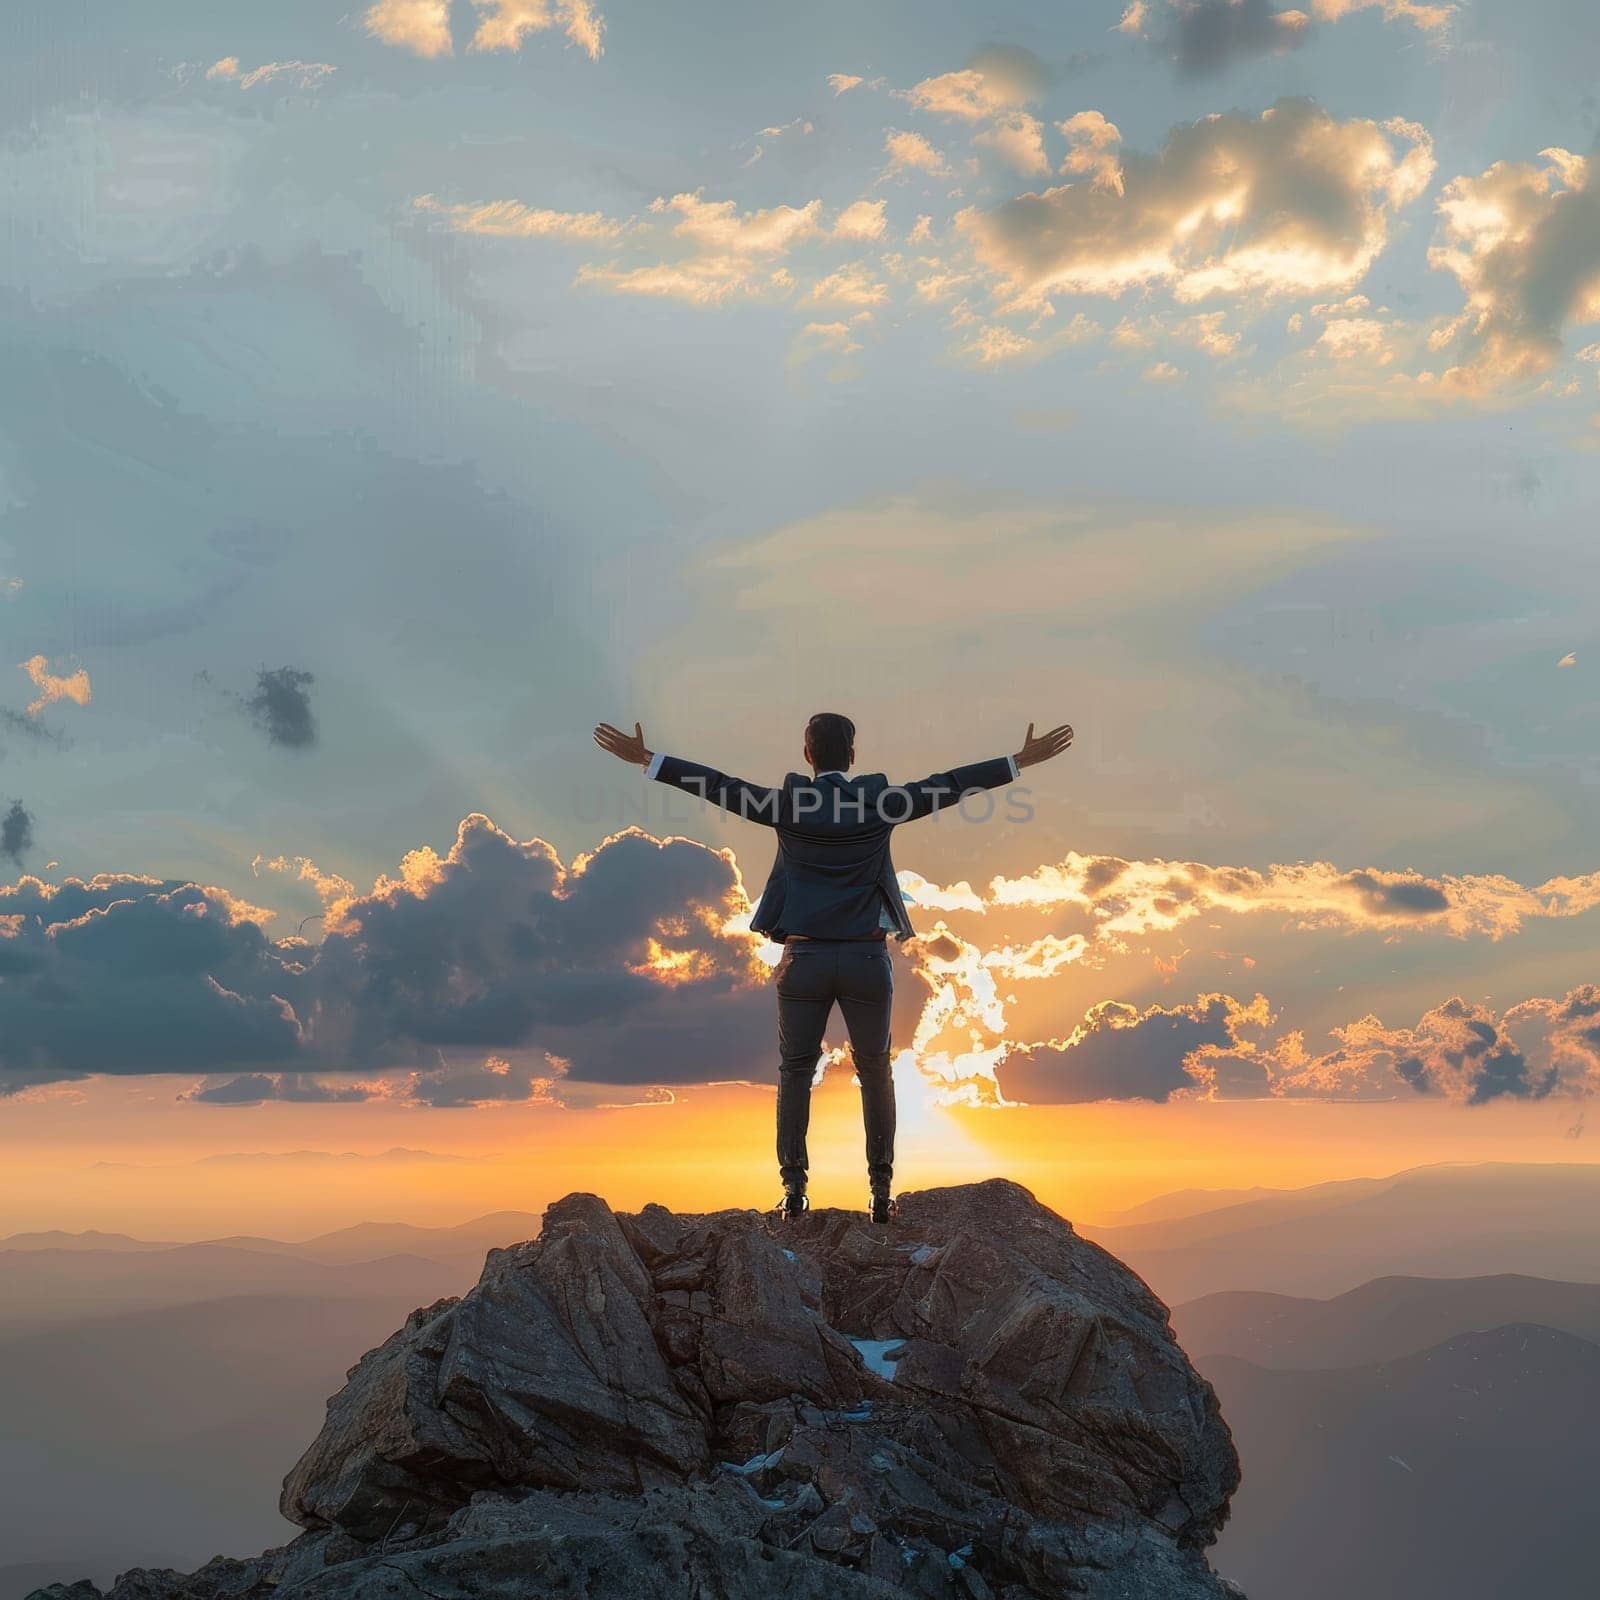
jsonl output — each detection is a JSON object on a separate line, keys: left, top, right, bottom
{"left": 1195, "top": 1325, "right": 1600, "bottom": 1600}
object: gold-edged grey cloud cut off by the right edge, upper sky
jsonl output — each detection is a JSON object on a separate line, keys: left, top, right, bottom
{"left": 1429, "top": 147, "right": 1600, "bottom": 390}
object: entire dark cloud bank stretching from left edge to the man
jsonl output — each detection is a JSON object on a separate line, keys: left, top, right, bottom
{"left": 0, "top": 816, "right": 771, "bottom": 1104}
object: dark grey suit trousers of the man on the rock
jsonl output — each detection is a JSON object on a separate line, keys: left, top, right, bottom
{"left": 774, "top": 939, "right": 894, "bottom": 1190}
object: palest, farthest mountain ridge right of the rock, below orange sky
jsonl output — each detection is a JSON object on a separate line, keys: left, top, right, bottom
{"left": 1082, "top": 1163, "right": 1600, "bottom": 1304}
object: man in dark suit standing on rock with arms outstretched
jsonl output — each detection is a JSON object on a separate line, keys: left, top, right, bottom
{"left": 595, "top": 712, "right": 1072, "bottom": 1222}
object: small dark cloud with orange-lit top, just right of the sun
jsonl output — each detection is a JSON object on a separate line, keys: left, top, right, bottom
{"left": 995, "top": 994, "right": 1272, "bottom": 1106}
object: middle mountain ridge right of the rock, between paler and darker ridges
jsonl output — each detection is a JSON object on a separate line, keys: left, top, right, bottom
{"left": 1173, "top": 1272, "right": 1600, "bottom": 1368}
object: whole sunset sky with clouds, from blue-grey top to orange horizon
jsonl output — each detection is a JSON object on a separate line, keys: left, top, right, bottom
{"left": 0, "top": 0, "right": 1600, "bottom": 1238}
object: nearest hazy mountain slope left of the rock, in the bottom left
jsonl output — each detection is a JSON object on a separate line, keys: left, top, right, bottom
{"left": 0, "top": 1293, "right": 428, "bottom": 1600}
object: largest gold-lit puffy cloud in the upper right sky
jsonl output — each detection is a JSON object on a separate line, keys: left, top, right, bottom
{"left": 957, "top": 99, "right": 1434, "bottom": 304}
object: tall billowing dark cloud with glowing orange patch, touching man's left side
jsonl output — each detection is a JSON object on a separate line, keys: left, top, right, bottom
{"left": 314, "top": 816, "right": 771, "bottom": 1083}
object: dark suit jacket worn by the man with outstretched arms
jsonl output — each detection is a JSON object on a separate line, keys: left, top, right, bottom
{"left": 656, "top": 755, "right": 1014, "bottom": 942}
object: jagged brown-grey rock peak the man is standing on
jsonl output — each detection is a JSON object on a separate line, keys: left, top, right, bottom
{"left": 31, "top": 1181, "right": 1238, "bottom": 1600}
